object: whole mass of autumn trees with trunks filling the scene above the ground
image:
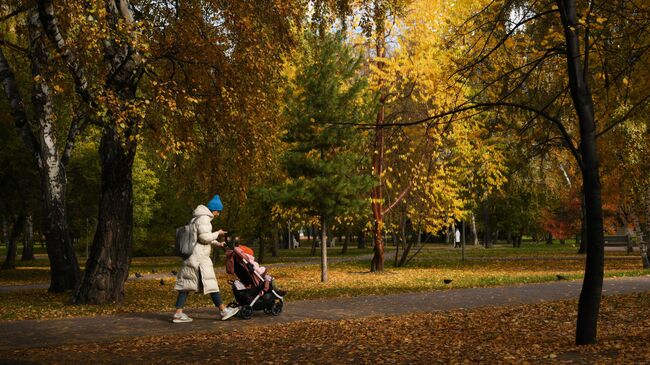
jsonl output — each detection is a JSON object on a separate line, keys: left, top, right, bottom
{"left": 0, "top": 0, "right": 650, "bottom": 344}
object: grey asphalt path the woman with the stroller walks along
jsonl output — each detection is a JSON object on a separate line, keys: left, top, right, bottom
{"left": 0, "top": 276, "right": 650, "bottom": 351}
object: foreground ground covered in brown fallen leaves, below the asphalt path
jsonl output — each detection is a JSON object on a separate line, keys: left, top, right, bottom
{"left": 1, "top": 293, "right": 650, "bottom": 364}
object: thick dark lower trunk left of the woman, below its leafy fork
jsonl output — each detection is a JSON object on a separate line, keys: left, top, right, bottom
{"left": 73, "top": 126, "right": 136, "bottom": 304}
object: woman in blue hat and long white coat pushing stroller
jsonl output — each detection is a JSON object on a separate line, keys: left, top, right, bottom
{"left": 172, "top": 195, "right": 239, "bottom": 323}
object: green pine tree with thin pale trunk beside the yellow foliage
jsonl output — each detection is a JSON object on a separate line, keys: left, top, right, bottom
{"left": 283, "top": 34, "right": 373, "bottom": 282}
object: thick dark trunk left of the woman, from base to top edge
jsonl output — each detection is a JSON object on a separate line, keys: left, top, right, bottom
{"left": 73, "top": 0, "right": 144, "bottom": 304}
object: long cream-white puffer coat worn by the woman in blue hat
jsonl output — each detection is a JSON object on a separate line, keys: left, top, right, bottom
{"left": 174, "top": 205, "right": 219, "bottom": 294}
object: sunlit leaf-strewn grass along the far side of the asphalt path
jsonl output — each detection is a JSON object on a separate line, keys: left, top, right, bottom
{"left": 0, "top": 255, "right": 648, "bottom": 321}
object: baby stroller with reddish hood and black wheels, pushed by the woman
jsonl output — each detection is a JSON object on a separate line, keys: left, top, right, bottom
{"left": 226, "top": 248, "right": 284, "bottom": 319}
